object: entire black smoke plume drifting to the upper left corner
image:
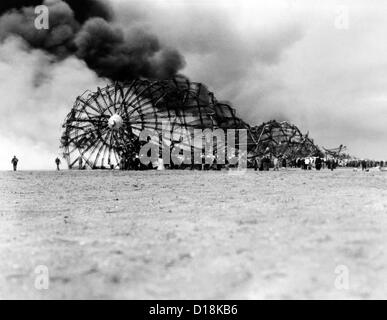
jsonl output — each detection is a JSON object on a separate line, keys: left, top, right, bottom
{"left": 0, "top": 0, "right": 184, "bottom": 81}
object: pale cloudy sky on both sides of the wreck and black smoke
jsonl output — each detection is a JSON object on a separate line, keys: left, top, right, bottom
{"left": 0, "top": 0, "right": 387, "bottom": 169}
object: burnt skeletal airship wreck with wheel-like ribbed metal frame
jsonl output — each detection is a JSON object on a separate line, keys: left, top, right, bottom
{"left": 61, "top": 77, "right": 340, "bottom": 170}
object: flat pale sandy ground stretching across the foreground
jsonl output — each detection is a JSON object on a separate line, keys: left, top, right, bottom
{"left": 0, "top": 169, "right": 387, "bottom": 299}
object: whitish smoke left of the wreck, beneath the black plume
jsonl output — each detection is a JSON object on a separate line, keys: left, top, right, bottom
{"left": 0, "top": 38, "right": 106, "bottom": 169}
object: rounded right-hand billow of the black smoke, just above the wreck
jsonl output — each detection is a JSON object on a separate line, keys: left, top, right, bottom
{"left": 75, "top": 18, "right": 183, "bottom": 81}
